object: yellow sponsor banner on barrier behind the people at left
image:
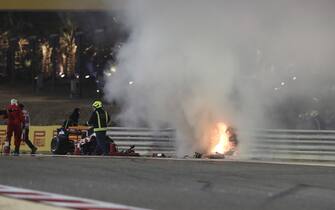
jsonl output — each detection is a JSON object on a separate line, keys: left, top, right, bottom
{"left": 0, "top": 125, "right": 60, "bottom": 152}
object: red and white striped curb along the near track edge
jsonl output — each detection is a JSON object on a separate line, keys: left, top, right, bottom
{"left": 0, "top": 185, "right": 145, "bottom": 210}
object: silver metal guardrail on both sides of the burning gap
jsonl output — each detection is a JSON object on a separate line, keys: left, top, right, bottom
{"left": 107, "top": 127, "right": 335, "bottom": 161}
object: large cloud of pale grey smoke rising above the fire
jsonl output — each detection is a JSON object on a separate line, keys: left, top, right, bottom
{"left": 105, "top": 0, "right": 335, "bottom": 155}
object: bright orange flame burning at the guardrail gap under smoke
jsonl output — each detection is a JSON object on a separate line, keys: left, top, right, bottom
{"left": 211, "top": 122, "right": 231, "bottom": 154}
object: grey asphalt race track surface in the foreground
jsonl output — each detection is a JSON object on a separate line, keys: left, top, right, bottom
{"left": 0, "top": 156, "right": 335, "bottom": 210}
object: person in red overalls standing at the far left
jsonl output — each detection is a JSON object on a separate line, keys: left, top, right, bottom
{"left": 4, "top": 99, "right": 23, "bottom": 155}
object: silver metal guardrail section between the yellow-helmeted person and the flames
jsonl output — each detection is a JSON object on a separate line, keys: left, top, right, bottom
{"left": 107, "top": 127, "right": 175, "bottom": 156}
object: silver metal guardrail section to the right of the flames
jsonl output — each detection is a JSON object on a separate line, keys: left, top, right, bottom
{"left": 243, "top": 130, "right": 335, "bottom": 161}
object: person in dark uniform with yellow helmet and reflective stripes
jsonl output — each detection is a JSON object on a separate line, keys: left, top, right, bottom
{"left": 88, "top": 101, "right": 110, "bottom": 155}
